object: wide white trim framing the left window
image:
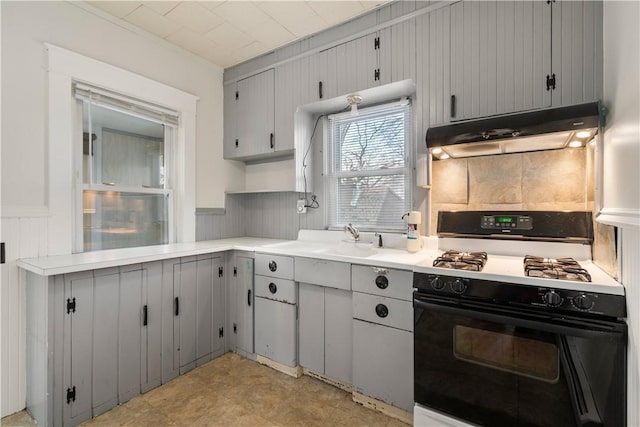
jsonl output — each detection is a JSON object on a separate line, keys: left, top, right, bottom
{"left": 44, "top": 43, "right": 198, "bottom": 255}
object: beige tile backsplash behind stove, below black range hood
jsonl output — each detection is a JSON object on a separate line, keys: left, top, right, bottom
{"left": 430, "top": 146, "right": 617, "bottom": 276}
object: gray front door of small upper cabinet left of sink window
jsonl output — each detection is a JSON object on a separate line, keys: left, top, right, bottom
{"left": 234, "top": 70, "right": 275, "bottom": 156}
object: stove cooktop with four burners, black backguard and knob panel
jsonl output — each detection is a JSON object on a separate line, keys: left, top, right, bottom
{"left": 414, "top": 211, "right": 626, "bottom": 318}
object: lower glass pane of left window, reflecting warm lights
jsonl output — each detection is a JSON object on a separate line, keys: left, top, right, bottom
{"left": 82, "top": 190, "right": 169, "bottom": 251}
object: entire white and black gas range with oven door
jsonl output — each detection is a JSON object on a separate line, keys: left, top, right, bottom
{"left": 413, "top": 212, "right": 627, "bottom": 426}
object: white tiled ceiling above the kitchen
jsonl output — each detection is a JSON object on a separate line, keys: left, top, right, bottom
{"left": 87, "top": 0, "right": 388, "bottom": 68}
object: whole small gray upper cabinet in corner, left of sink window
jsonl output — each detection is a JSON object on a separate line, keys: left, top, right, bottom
{"left": 223, "top": 69, "right": 276, "bottom": 160}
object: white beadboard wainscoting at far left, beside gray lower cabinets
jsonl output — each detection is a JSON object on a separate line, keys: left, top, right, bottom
{"left": 0, "top": 211, "right": 49, "bottom": 417}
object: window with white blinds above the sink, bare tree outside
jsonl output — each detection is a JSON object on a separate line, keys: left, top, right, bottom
{"left": 326, "top": 100, "right": 412, "bottom": 231}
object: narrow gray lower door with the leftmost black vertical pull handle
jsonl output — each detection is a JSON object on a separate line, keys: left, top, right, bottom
{"left": 140, "top": 261, "right": 162, "bottom": 393}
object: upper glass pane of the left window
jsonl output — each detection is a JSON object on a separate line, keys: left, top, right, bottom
{"left": 83, "top": 102, "right": 165, "bottom": 188}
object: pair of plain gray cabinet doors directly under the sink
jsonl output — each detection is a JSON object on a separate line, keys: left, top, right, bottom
{"left": 298, "top": 283, "right": 353, "bottom": 384}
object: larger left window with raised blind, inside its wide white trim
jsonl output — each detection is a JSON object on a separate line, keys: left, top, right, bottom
{"left": 75, "top": 85, "right": 178, "bottom": 251}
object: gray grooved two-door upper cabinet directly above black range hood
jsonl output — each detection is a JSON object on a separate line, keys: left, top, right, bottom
{"left": 450, "top": 1, "right": 602, "bottom": 120}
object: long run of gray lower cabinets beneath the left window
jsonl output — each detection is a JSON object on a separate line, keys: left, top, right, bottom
{"left": 26, "top": 254, "right": 225, "bottom": 426}
